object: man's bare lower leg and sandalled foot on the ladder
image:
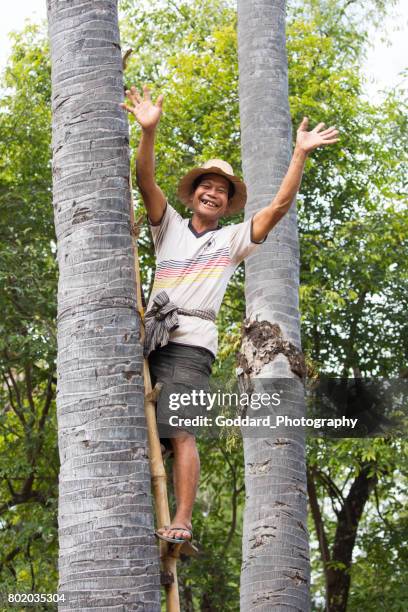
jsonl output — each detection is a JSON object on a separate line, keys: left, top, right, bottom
{"left": 158, "top": 432, "right": 200, "bottom": 539}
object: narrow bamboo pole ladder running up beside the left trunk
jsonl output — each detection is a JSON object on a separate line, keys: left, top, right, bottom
{"left": 129, "top": 170, "right": 197, "bottom": 612}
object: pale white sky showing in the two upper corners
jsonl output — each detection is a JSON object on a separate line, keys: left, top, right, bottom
{"left": 0, "top": 0, "right": 408, "bottom": 98}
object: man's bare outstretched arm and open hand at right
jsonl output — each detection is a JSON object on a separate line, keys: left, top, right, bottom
{"left": 252, "top": 117, "right": 339, "bottom": 242}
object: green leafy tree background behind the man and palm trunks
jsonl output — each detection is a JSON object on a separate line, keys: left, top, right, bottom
{"left": 0, "top": 0, "right": 408, "bottom": 612}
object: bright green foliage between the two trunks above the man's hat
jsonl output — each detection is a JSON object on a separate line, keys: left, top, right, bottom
{"left": 121, "top": 0, "right": 240, "bottom": 201}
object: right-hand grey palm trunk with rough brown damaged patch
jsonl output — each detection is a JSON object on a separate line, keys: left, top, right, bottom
{"left": 238, "top": 0, "right": 310, "bottom": 612}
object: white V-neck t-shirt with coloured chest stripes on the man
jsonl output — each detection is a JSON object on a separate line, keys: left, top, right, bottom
{"left": 147, "top": 203, "right": 261, "bottom": 355}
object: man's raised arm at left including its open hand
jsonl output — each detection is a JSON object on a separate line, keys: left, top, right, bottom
{"left": 121, "top": 85, "right": 166, "bottom": 225}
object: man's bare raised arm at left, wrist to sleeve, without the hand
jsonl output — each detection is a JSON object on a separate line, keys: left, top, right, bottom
{"left": 136, "top": 129, "right": 166, "bottom": 225}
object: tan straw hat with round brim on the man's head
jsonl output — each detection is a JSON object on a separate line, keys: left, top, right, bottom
{"left": 177, "top": 159, "right": 247, "bottom": 215}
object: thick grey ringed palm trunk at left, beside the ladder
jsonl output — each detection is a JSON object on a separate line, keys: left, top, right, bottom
{"left": 48, "top": 0, "right": 160, "bottom": 611}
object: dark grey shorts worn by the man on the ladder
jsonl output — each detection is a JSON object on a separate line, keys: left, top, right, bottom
{"left": 149, "top": 342, "right": 214, "bottom": 448}
